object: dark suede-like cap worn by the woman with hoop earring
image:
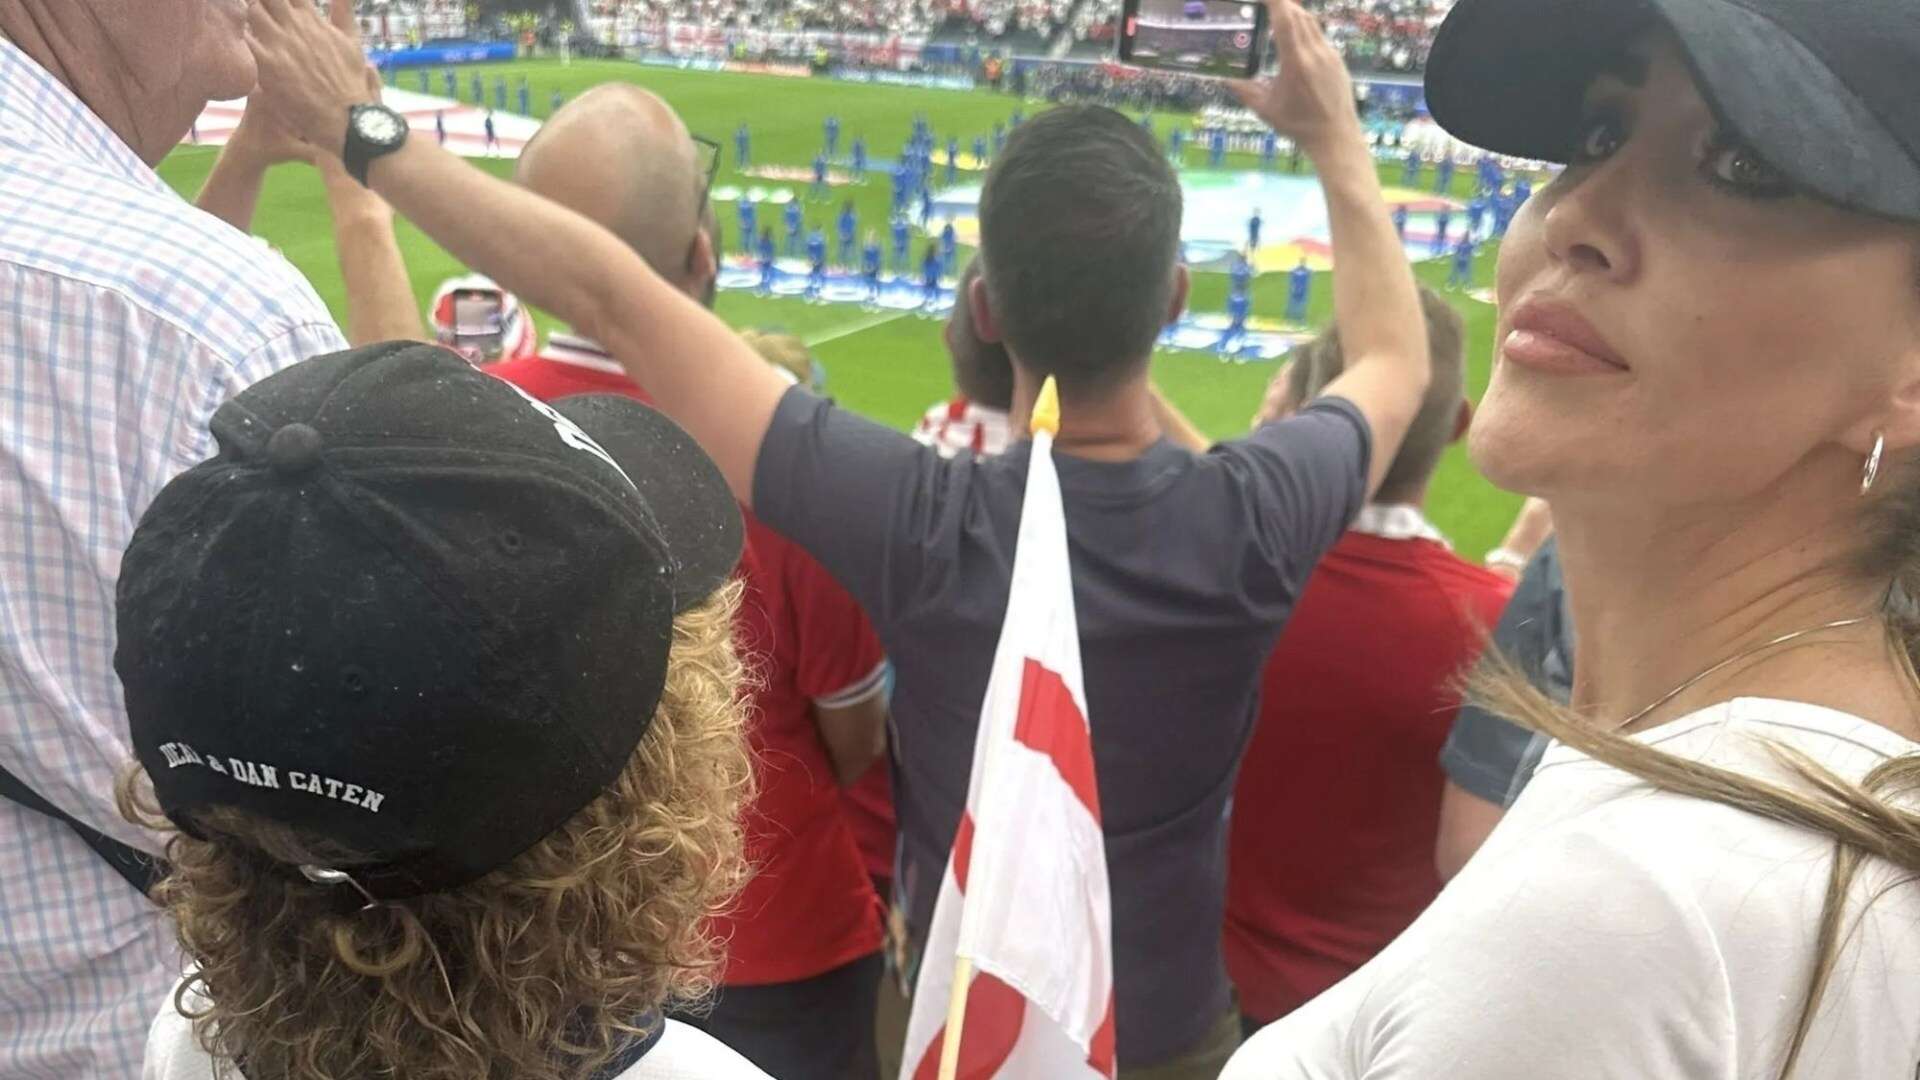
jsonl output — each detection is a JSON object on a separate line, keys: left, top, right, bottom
{"left": 1427, "top": 0, "right": 1920, "bottom": 221}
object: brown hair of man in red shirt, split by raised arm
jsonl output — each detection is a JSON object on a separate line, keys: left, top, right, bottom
{"left": 1294, "top": 286, "right": 1467, "bottom": 502}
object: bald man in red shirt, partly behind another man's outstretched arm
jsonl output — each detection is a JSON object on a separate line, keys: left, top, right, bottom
{"left": 488, "top": 83, "right": 885, "bottom": 1080}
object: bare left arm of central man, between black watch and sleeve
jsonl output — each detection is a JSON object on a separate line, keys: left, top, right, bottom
{"left": 371, "top": 138, "right": 787, "bottom": 502}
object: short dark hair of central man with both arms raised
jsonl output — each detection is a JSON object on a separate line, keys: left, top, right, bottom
{"left": 979, "top": 106, "right": 1181, "bottom": 396}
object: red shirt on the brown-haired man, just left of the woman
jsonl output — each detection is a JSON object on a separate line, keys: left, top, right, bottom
{"left": 1225, "top": 532, "right": 1513, "bottom": 1020}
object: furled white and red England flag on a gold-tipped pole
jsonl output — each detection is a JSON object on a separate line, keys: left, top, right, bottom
{"left": 900, "top": 379, "right": 1114, "bottom": 1080}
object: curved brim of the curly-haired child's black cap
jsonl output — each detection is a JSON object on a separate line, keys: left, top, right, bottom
{"left": 553, "top": 394, "right": 745, "bottom": 613}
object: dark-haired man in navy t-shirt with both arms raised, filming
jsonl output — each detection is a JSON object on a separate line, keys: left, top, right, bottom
{"left": 252, "top": 0, "right": 1428, "bottom": 1078}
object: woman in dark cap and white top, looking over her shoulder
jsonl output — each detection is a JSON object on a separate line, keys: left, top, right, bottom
{"left": 1225, "top": 0, "right": 1920, "bottom": 1080}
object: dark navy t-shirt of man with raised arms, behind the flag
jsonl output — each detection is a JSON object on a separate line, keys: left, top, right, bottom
{"left": 753, "top": 388, "right": 1371, "bottom": 1067}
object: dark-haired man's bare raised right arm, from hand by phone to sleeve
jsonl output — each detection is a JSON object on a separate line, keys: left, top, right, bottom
{"left": 1235, "top": 0, "right": 1432, "bottom": 496}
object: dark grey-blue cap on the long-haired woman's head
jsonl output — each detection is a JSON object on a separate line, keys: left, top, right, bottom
{"left": 1427, "top": 0, "right": 1920, "bottom": 221}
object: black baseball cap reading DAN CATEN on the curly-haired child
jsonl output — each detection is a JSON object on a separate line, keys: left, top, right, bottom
{"left": 113, "top": 344, "right": 741, "bottom": 899}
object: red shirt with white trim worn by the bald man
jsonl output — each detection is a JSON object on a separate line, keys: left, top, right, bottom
{"left": 484, "top": 343, "right": 885, "bottom": 986}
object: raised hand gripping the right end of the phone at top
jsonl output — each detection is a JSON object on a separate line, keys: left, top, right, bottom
{"left": 1233, "top": 0, "right": 1363, "bottom": 158}
